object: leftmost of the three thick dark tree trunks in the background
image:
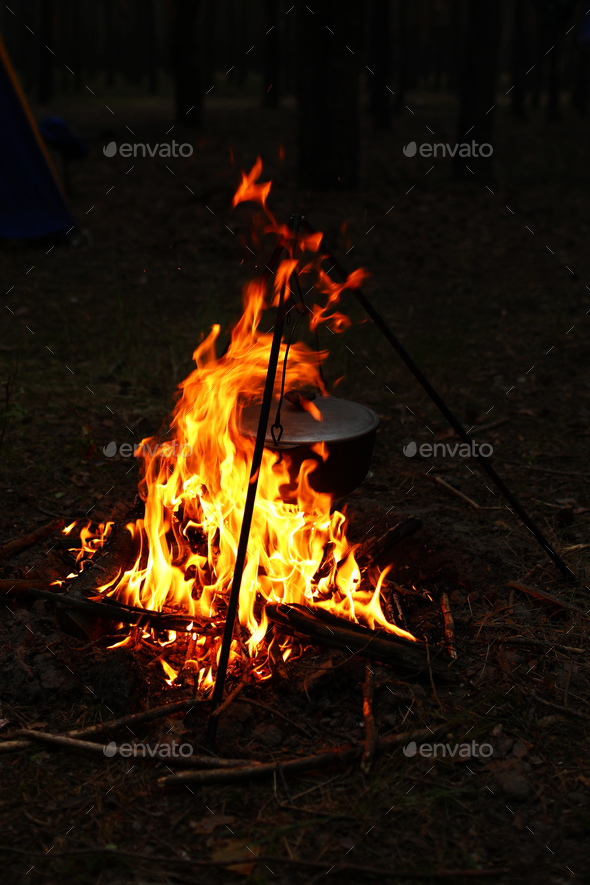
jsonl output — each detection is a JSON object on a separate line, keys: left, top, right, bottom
{"left": 171, "top": 0, "right": 203, "bottom": 129}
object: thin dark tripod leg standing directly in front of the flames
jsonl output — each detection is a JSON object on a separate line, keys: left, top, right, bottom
{"left": 205, "top": 283, "right": 286, "bottom": 749}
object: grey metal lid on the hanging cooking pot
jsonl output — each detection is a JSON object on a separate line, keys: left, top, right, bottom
{"left": 240, "top": 396, "right": 379, "bottom": 448}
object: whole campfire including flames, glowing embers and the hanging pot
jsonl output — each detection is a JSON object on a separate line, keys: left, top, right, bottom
{"left": 56, "top": 161, "right": 430, "bottom": 690}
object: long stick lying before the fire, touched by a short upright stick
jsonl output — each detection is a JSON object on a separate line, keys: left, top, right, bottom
{"left": 158, "top": 725, "right": 448, "bottom": 787}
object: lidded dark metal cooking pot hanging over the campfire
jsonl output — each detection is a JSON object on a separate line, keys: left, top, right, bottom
{"left": 241, "top": 394, "right": 379, "bottom": 500}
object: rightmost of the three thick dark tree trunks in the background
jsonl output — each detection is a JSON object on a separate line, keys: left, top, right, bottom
{"left": 453, "top": 0, "right": 501, "bottom": 179}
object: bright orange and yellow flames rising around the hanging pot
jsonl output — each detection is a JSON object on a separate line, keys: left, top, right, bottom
{"left": 63, "top": 160, "right": 413, "bottom": 686}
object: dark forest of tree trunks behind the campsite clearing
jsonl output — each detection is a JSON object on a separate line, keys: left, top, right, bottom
{"left": 0, "top": 0, "right": 590, "bottom": 188}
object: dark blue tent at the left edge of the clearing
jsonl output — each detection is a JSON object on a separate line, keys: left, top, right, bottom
{"left": 0, "top": 37, "right": 76, "bottom": 239}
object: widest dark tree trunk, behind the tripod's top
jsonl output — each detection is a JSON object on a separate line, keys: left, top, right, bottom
{"left": 300, "top": 0, "right": 364, "bottom": 189}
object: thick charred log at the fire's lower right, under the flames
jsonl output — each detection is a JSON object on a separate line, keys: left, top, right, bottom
{"left": 266, "top": 604, "right": 448, "bottom": 679}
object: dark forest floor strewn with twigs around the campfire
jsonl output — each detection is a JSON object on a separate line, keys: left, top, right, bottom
{"left": 0, "top": 95, "right": 590, "bottom": 885}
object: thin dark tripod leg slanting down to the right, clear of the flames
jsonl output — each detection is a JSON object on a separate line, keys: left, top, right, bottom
{"left": 302, "top": 219, "right": 575, "bottom": 580}
